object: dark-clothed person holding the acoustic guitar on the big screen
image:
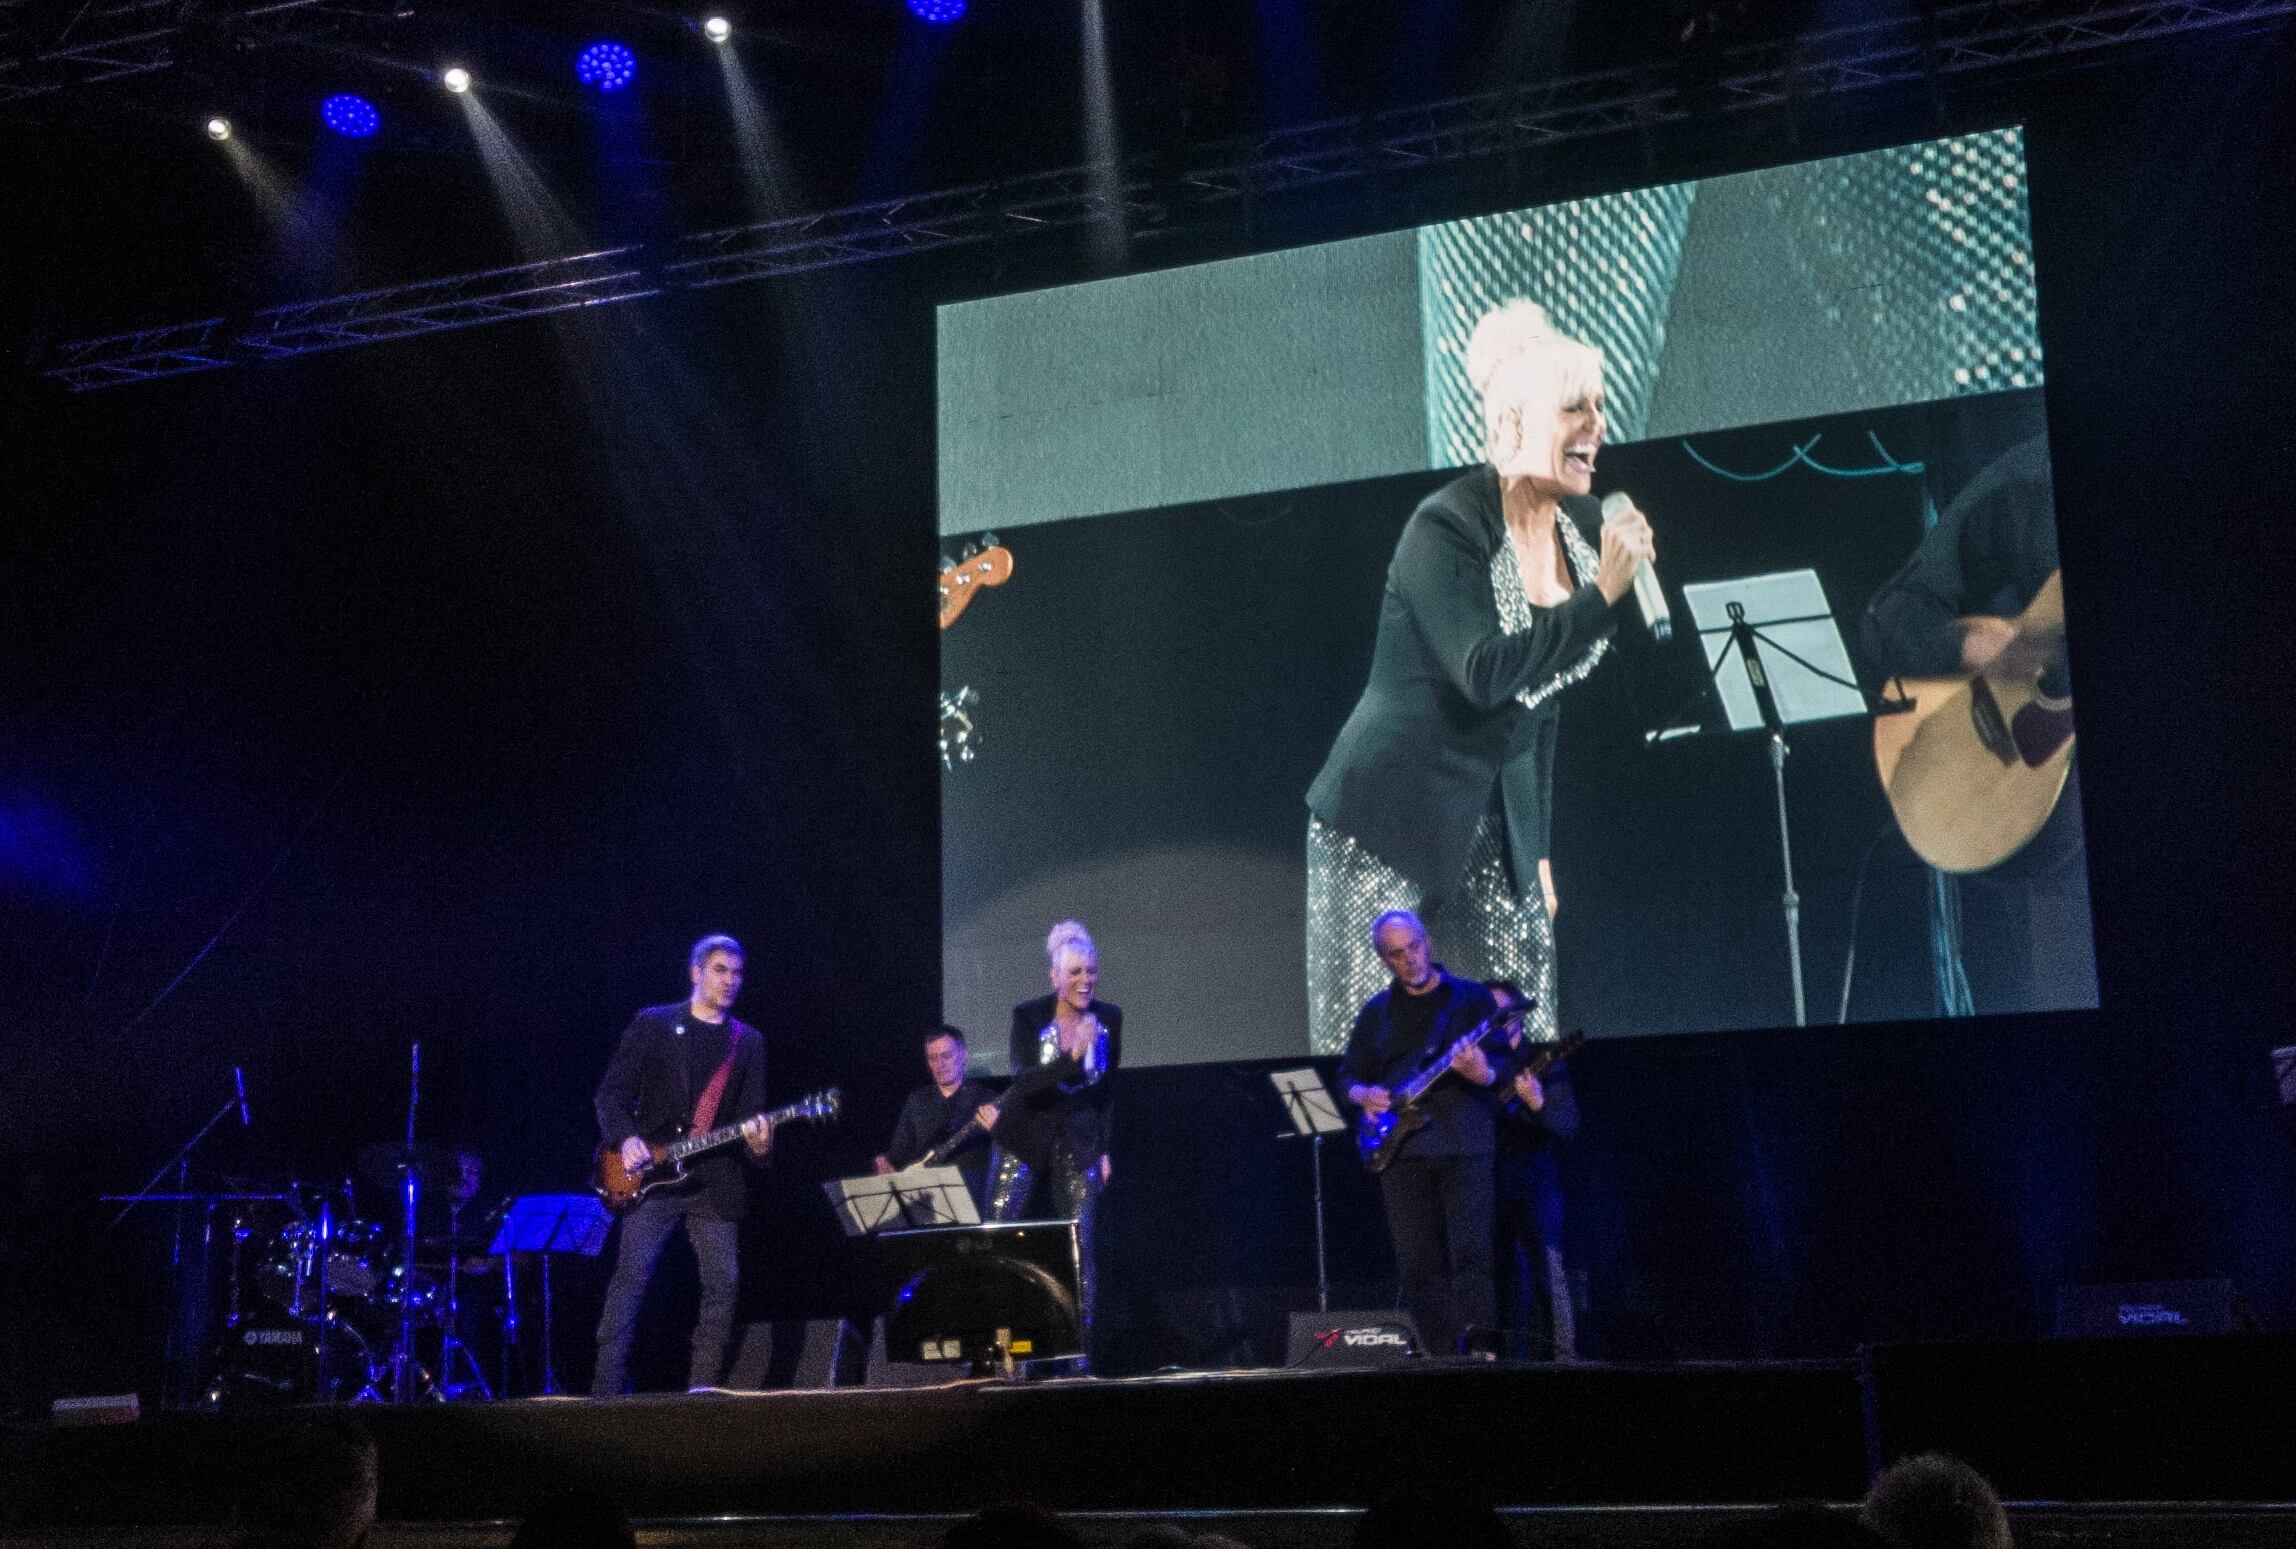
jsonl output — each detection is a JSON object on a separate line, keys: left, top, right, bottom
{"left": 1864, "top": 434, "right": 2096, "bottom": 1014}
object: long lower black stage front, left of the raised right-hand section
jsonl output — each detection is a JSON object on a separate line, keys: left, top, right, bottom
{"left": 16, "top": 1363, "right": 1864, "bottom": 1528}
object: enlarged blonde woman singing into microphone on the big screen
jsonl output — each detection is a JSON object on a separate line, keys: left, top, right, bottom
{"left": 1306, "top": 301, "right": 1653, "bottom": 1053}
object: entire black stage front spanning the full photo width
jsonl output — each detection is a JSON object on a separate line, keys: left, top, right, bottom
{"left": 13, "top": 1336, "right": 2296, "bottom": 1533}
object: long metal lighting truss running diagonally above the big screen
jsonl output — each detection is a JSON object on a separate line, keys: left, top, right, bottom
{"left": 40, "top": 0, "right": 2296, "bottom": 390}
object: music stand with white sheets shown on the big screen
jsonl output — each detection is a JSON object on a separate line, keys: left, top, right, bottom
{"left": 1644, "top": 569, "right": 1874, "bottom": 1028}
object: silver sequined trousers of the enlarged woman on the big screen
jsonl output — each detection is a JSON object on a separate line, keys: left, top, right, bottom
{"left": 1306, "top": 812, "right": 1554, "bottom": 1053}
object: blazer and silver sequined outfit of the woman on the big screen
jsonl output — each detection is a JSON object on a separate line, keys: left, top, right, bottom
{"left": 1306, "top": 468, "right": 1612, "bottom": 1053}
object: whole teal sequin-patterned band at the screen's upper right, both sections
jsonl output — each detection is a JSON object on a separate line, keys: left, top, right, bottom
{"left": 1419, "top": 129, "right": 2041, "bottom": 466}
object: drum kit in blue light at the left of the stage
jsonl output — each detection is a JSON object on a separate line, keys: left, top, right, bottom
{"left": 197, "top": 1143, "right": 503, "bottom": 1409}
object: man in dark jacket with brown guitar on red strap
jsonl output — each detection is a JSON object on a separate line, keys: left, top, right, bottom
{"left": 590, "top": 936, "right": 774, "bottom": 1398}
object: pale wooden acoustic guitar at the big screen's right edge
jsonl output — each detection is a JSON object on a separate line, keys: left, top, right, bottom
{"left": 1874, "top": 571, "right": 2073, "bottom": 872}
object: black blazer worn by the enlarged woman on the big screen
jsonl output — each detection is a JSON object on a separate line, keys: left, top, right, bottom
{"left": 1306, "top": 468, "right": 1614, "bottom": 900}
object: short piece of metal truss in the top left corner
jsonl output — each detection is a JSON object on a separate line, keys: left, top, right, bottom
{"left": 0, "top": 0, "right": 324, "bottom": 106}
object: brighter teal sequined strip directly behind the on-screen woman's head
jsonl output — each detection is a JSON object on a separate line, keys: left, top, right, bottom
{"left": 1419, "top": 184, "right": 1697, "bottom": 468}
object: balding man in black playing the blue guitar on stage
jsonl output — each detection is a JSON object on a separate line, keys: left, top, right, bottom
{"left": 1339, "top": 909, "right": 1504, "bottom": 1356}
